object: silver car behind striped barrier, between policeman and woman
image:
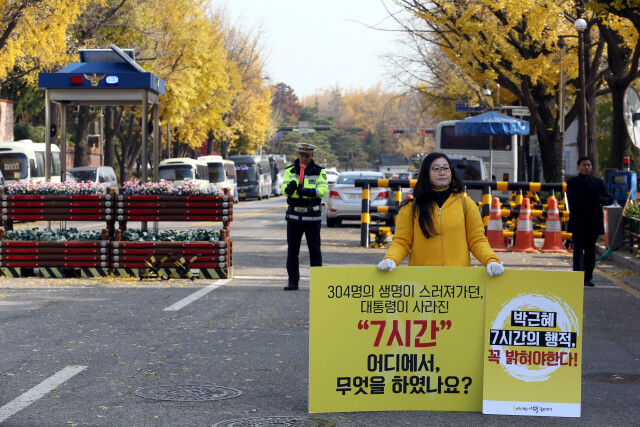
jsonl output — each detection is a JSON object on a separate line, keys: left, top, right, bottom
{"left": 325, "top": 171, "right": 394, "bottom": 227}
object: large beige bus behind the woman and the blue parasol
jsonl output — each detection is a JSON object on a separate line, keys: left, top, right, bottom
{"left": 435, "top": 120, "right": 518, "bottom": 182}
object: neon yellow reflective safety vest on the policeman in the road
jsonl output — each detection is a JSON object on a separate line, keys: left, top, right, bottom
{"left": 282, "top": 160, "right": 329, "bottom": 222}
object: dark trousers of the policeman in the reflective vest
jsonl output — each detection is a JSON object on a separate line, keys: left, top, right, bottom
{"left": 287, "top": 221, "right": 322, "bottom": 288}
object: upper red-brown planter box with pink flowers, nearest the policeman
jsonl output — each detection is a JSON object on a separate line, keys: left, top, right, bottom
{"left": 116, "top": 194, "right": 233, "bottom": 226}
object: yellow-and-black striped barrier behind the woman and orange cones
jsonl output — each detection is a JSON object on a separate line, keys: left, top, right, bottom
{"left": 355, "top": 179, "right": 570, "bottom": 247}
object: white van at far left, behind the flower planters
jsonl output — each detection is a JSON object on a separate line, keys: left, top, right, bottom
{"left": 0, "top": 139, "right": 60, "bottom": 185}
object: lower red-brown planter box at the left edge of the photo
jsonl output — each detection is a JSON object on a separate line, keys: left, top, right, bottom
{"left": 0, "top": 240, "right": 110, "bottom": 277}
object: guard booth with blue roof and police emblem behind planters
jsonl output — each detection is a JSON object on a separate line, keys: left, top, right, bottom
{"left": 39, "top": 44, "right": 165, "bottom": 182}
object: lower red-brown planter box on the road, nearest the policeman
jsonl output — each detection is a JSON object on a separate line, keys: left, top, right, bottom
{"left": 111, "top": 240, "right": 233, "bottom": 279}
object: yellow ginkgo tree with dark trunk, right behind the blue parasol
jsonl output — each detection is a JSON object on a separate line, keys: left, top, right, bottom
{"left": 398, "top": 0, "right": 595, "bottom": 182}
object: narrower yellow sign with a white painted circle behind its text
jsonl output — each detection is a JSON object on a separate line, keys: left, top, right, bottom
{"left": 483, "top": 270, "right": 584, "bottom": 417}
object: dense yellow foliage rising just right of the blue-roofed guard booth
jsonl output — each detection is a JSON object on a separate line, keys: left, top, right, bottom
{"left": 134, "top": 0, "right": 237, "bottom": 148}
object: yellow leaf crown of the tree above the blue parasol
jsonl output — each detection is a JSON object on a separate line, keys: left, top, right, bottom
{"left": 399, "top": 0, "right": 577, "bottom": 109}
